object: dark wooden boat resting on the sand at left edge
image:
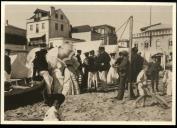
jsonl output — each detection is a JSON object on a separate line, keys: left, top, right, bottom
{"left": 4, "top": 77, "right": 45, "bottom": 110}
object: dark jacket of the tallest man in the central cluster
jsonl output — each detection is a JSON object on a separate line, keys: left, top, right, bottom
{"left": 96, "top": 52, "right": 111, "bottom": 71}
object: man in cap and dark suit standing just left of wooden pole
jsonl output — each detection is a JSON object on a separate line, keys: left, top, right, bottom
{"left": 115, "top": 51, "right": 129, "bottom": 100}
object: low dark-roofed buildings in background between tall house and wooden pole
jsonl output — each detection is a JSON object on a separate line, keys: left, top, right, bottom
{"left": 72, "top": 25, "right": 117, "bottom": 45}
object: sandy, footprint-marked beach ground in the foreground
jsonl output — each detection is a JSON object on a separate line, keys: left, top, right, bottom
{"left": 5, "top": 82, "right": 172, "bottom": 121}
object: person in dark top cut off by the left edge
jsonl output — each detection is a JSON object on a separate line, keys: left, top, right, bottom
{"left": 4, "top": 49, "right": 11, "bottom": 81}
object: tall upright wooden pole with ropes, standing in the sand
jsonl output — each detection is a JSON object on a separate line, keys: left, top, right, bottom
{"left": 128, "top": 16, "right": 135, "bottom": 99}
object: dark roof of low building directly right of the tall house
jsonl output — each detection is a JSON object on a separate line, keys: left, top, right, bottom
{"left": 72, "top": 25, "right": 91, "bottom": 33}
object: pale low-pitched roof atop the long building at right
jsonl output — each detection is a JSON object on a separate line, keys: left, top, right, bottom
{"left": 140, "top": 23, "right": 172, "bottom": 31}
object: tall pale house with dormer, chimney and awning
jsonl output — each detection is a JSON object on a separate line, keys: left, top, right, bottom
{"left": 26, "top": 7, "right": 71, "bottom": 46}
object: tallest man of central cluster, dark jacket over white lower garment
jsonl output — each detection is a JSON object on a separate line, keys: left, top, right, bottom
{"left": 96, "top": 47, "right": 111, "bottom": 87}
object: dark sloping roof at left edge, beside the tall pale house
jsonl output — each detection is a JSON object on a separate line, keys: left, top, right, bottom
{"left": 5, "top": 25, "right": 26, "bottom": 37}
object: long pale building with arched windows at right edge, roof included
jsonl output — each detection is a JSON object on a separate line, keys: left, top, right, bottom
{"left": 132, "top": 23, "right": 172, "bottom": 66}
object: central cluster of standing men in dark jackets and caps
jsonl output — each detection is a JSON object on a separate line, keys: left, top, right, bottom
{"left": 76, "top": 47, "right": 111, "bottom": 92}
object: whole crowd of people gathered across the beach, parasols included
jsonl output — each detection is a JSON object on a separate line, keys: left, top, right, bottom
{"left": 5, "top": 42, "right": 170, "bottom": 119}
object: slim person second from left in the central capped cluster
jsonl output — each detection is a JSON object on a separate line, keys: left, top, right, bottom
{"left": 82, "top": 52, "right": 89, "bottom": 90}
